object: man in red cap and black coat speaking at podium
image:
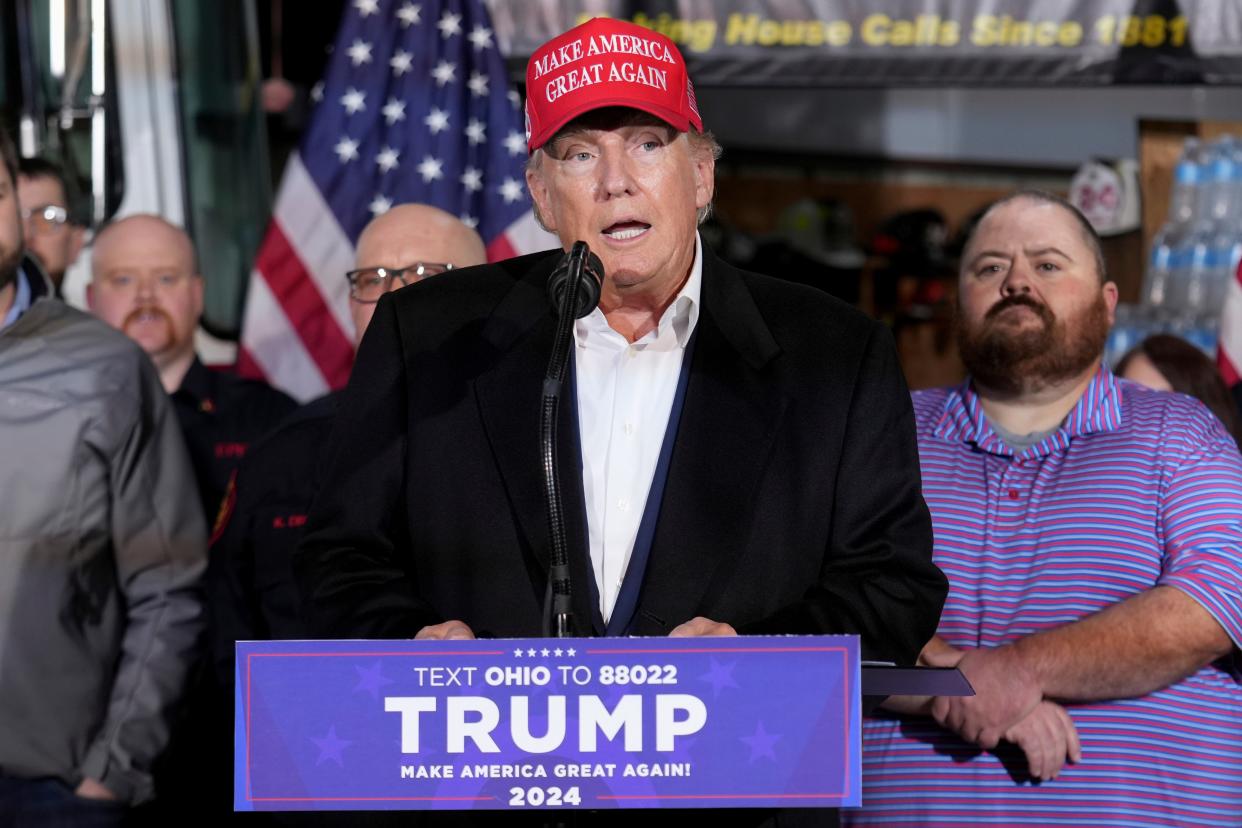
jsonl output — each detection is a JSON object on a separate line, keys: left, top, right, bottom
{"left": 298, "top": 19, "right": 945, "bottom": 824}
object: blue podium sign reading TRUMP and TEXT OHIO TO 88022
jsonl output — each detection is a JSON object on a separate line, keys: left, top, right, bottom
{"left": 233, "top": 636, "right": 861, "bottom": 811}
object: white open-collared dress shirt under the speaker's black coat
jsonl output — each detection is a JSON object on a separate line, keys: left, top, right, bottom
{"left": 574, "top": 236, "right": 703, "bottom": 623}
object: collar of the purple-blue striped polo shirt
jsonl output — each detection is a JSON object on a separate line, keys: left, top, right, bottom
{"left": 933, "top": 365, "right": 1122, "bottom": 457}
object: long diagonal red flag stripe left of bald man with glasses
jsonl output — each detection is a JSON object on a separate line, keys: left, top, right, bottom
{"left": 255, "top": 221, "right": 354, "bottom": 389}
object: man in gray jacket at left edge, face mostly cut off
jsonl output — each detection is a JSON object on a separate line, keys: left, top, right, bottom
{"left": 0, "top": 129, "right": 206, "bottom": 828}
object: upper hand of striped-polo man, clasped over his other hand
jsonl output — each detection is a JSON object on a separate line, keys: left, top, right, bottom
{"left": 923, "top": 647, "right": 1043, "bottom": 750}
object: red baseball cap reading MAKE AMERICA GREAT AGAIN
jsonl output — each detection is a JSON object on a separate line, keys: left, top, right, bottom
{"left": 527, "top": 17, "right": 703, "bottom": 153}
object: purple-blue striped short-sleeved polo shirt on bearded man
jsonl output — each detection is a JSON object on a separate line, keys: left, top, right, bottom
{"left": 845, "top": 370, "right": 1242, "bottom": 828}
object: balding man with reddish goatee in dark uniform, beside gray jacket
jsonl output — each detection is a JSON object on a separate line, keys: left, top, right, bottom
{"left": 87, "top": 215, "right": 296, "bottom": 526}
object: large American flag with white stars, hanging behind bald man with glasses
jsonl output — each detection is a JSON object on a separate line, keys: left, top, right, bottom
{"left": 237, "top": 0, "right": 556, "bottom": 400}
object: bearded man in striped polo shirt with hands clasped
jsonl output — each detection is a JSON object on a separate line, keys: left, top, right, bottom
{"left": 851, "top": 191, "right": 1242, "bottom": 826}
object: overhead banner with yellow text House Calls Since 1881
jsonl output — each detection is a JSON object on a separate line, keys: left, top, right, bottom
{"left": 488, "top": 0, "right": 1242, "bottom": 87}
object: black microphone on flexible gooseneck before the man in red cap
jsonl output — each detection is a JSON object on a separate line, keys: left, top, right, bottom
{"left": 539, "top": 242, "right": 604, "bottom": 638}
